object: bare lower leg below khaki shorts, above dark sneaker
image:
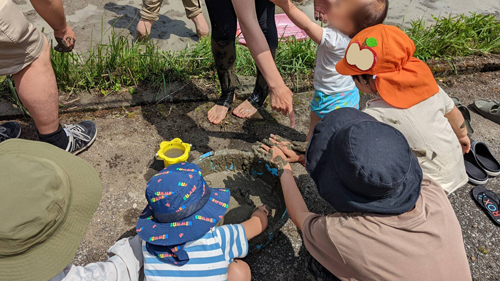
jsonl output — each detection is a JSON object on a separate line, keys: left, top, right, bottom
{"left": 14, "top": 39, "right": 59, "bottom": 134}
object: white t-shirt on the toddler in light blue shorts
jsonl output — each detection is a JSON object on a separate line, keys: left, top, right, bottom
{"left": 314, "top": 27, "right": 356, "bottom": 95}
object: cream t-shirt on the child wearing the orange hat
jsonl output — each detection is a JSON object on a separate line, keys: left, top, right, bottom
{"left": 364, "top": 87, "right": 468, "bottom": 194}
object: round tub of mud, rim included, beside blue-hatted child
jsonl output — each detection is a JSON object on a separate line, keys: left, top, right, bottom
{"left": 194, "top": 149, "right": 288, "bottom": 251}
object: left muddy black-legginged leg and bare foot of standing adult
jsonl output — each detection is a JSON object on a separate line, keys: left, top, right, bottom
{"left": 205, "top": 0, "right": 238, "bottom": 124}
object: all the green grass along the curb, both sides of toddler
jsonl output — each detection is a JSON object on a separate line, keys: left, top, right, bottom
{"left": 0, "top": 13, "right": 500, "bottom": 99}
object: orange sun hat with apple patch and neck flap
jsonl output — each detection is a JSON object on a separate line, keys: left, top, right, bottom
{"left": 336, "top": 24, "right": 439, "bottom": 108}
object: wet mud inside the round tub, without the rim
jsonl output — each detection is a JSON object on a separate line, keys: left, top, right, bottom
{"left": 204, "top": 172, "right": 281, "bottom": 225}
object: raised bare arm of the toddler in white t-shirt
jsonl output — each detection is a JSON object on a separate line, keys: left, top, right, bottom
{"left": 270, "top": 0, "right": 323, "bottom": 44}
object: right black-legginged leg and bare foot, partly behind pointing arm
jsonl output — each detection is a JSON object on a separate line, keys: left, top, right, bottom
{"left": 233, "top": 0, "right": 278, "bottom": 118}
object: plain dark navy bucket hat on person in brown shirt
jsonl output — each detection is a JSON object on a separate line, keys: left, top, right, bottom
{"left": 306, "top": 108, "right": 423, "bottom": 215}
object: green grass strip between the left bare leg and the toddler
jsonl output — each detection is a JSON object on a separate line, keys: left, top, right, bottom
{"left": 51, "top": 31, "right": 316, "bottom": 95}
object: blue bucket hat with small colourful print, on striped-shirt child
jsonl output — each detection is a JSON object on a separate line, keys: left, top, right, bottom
{"left": 136, "top": 162, "right": 231, "bottom": 248}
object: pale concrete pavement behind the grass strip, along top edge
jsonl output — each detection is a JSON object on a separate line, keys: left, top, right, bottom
{"left": 14, "top": 0, "right": 500, "bottom": 52}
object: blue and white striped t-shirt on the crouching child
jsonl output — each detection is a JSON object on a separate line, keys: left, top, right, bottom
{"left": 142, "top": 224, "right": 248, "bottom": 281}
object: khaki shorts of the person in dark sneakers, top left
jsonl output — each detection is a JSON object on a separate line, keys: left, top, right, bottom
{"left": 0, "top": 0, "right": 46, "bottom": 76}
